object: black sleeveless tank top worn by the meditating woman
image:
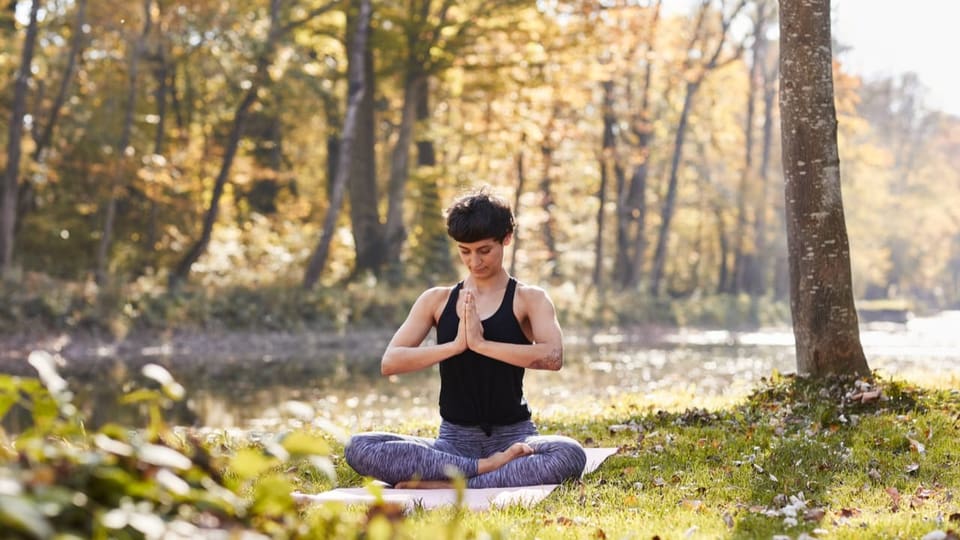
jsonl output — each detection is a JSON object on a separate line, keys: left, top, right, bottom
{"left": 437, "top": 278, "right": 530, "bottom": 435}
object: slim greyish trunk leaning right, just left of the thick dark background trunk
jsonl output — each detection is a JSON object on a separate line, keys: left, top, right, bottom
{"left": 303, "top": 0, "right": 371, "bottom": 289}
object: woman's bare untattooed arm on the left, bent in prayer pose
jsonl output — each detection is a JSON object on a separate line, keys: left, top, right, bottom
{"left": 380, "top": 287, "right": 466, "bottom": 375}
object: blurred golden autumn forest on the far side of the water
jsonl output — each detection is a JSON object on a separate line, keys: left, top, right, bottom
{"left": 0, "top": 0, "right": 960, "bottom": 336}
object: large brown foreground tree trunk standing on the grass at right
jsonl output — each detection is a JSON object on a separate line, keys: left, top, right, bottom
{"left": 780, "top": 0, "right": 870, "bottom": 376}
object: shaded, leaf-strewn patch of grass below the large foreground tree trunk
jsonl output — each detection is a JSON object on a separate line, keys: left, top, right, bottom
{"left": 732, "top": 376, "right": 925, "bottom": 538}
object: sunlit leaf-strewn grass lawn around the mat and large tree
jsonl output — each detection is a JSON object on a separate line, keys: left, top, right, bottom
{"left": 299, "top": 376, "right": 960, "bottom": 539}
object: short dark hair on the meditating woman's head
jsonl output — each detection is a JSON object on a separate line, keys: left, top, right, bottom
{"left": 446, "top": 188, "right": 515, "bottom": 243}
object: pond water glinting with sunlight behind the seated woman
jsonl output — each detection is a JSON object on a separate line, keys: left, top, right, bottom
{"left": 5, "top": 312, "right": 960, "bottom": 431}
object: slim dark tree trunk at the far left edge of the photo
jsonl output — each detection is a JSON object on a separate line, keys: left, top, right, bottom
{"left": 0, "top": 0, "right": 40, "bottom": 275}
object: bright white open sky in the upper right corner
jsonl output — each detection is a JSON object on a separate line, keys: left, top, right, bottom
{"left": 832, "top": 0, "right": 960, "bottom": 117}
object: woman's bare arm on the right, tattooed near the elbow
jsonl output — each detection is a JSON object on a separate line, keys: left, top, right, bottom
{"left": 465, "top": 287, "right": 563, "bottom": 371}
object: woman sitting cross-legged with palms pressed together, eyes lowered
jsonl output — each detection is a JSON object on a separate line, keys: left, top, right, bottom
{"left": 346, "top": 190, "right": 586, "bottom": 488}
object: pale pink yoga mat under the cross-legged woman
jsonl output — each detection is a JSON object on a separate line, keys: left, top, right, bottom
{"left": 293, "top": 448, "right": 617, "bottom": 511}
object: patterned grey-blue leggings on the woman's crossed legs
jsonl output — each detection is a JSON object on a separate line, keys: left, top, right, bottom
{"left": 346, "top": 420, "right": 587, "bottom": 488}
